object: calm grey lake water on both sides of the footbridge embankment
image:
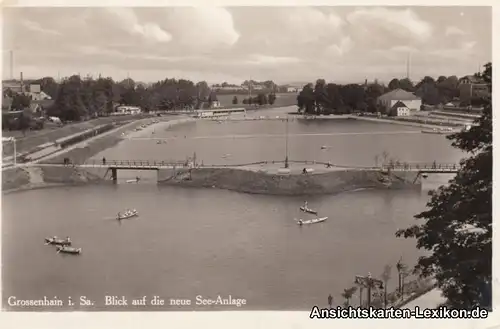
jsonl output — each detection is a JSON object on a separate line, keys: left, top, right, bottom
{"left": 2, "top": 107, "right": 461, "bottom": 311}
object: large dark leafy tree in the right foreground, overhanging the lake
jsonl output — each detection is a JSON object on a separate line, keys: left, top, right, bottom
{"left": 397, "top": 63, "right": 493, "bottom": 309}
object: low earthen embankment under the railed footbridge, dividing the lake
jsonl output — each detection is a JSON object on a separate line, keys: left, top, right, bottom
{"left": 2, "top": 165, "right": 421, "bottom": 196}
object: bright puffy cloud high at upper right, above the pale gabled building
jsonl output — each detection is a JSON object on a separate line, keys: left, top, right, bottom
{"left": 347, "top": 7, "right": 433, "bottom": 41}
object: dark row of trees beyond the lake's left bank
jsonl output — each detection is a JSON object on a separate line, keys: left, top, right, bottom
{"left": 5, "top": 75, "right": 215, "bottom": 121}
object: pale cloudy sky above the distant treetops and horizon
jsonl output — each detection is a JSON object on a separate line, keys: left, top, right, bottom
{"left": 2, "top": 6, "right": 492, "bottom": 84}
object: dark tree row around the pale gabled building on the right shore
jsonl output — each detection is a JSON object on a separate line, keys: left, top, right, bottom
{"left": 297, "top": 74, "right": 481, "bottom": 114}
